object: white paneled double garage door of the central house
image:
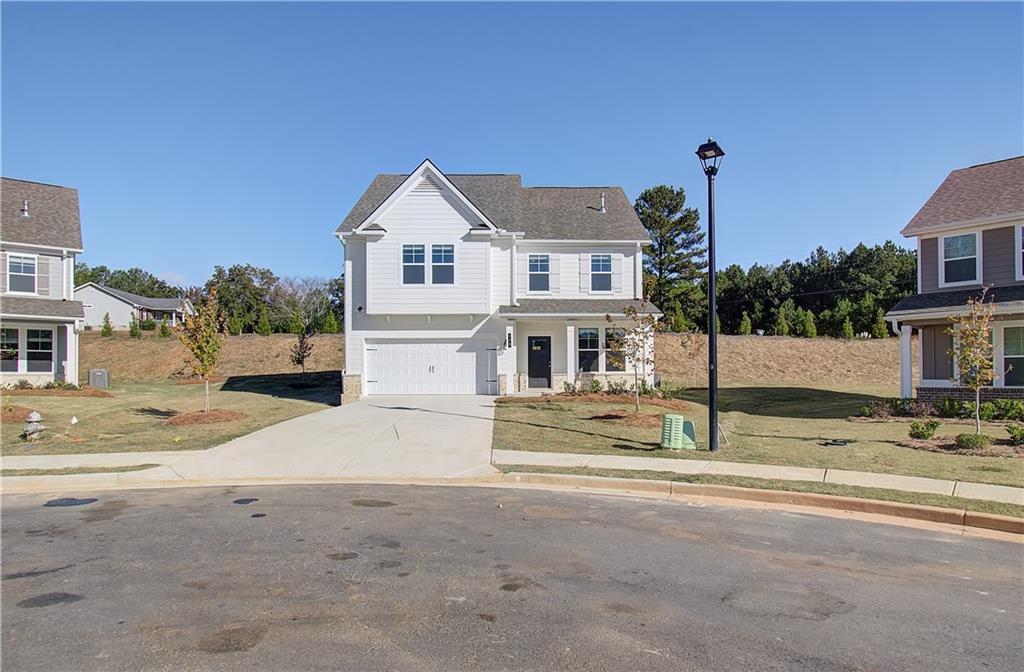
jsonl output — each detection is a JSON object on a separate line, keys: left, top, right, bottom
{"left": 367, "top": 340, "right": 497, "bottom": 394}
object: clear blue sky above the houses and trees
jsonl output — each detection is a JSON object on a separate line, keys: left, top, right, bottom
{"left": 2, "top": 2, "right": 1024, "bottom": 284}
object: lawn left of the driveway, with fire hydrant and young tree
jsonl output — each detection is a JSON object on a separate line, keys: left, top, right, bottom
{"left": 2, "top": 373, "right": 340, "bottom": 455}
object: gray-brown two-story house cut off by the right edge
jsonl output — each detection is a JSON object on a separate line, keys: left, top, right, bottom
{"left": 886, "top": 157, "right": 1024, "bottom": 400}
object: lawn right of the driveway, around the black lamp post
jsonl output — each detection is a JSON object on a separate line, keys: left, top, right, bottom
{"left": 494, "top": 387, "right": 1024, "bottom": 487}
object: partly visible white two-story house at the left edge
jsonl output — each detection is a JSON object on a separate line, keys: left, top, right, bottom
{"left": 0, "top": 177, "right": 84, "bottom": 385}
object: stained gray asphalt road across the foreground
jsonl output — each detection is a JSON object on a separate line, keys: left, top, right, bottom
{"left": 0, "top": 486, "right": 1024, "bottom": 672}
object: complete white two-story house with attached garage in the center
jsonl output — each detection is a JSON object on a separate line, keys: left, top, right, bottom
{"left": 336, "top": 160, "right": 656, "bottom": 402}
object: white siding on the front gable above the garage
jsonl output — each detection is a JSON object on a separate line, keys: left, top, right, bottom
{"left": 366, "top": 178, "right": 490, "bottom": 314}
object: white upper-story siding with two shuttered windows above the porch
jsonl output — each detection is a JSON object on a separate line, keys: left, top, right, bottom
{"left": 516, "top": 243, "right": 636, "bottom": 299}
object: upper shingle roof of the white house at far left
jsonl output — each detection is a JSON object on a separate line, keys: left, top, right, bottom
{"left": 0, "top": 177, "right": 82, "bottom": 250}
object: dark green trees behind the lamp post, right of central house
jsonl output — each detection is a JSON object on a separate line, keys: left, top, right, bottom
{"left": 634, "top": 184, "right": 918, "bottom": 338}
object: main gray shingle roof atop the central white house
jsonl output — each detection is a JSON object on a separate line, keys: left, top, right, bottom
{"left": 338, "top": 174, "right": 648, "bottom": 241}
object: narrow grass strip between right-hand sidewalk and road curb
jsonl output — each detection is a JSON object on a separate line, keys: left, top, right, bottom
{"left": 496, "top": 464, "right": 1024, "bottom": 518}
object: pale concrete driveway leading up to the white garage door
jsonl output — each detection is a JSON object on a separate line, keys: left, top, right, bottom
{"left": 165, "top": 395, "right": 497, "bottom": 480}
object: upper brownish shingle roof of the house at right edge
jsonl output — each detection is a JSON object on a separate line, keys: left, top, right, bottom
{"left": 902, "top": 157, "right": 1024, "bottom": 236}
